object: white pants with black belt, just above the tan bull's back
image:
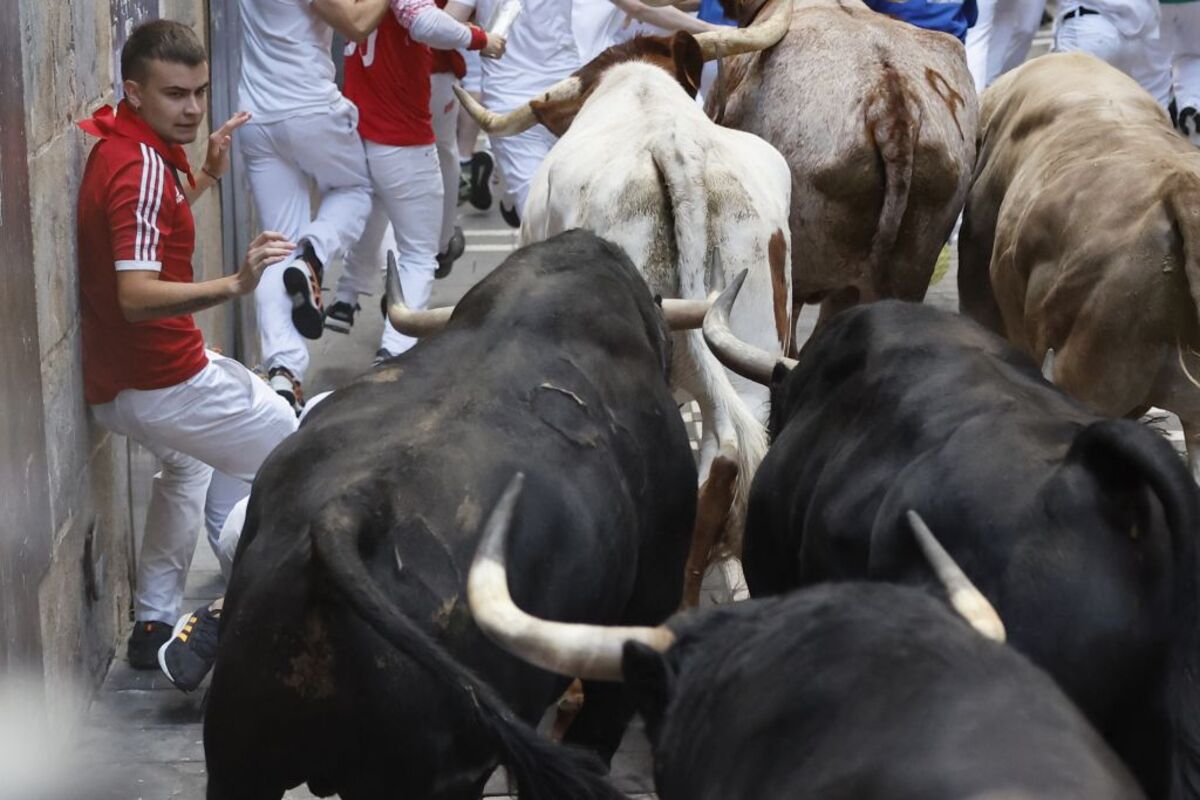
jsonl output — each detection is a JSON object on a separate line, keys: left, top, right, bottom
{"left": 1054, "top": 7, "right": 1171, "bottom": 108}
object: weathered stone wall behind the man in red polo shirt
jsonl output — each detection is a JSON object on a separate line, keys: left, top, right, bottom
{"left": 17, "top": 0, "right": 233, "bottom": 712}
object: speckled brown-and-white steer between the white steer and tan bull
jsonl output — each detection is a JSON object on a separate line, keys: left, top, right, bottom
{"left": 708, "top": 0, "right": 978, "bottom": 328}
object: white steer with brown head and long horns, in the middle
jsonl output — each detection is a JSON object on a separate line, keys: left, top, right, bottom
{"left": 460, "top": 7, "right": 792, "bottom": 604}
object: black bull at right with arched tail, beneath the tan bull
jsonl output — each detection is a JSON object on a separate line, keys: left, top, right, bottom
{"left": 744, "top": 302, "right": 1200, "bottom": 798}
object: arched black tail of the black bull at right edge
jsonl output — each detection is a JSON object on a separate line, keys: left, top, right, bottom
{"left": 1072, "top": 420, "right": 1200, "bottom": 800}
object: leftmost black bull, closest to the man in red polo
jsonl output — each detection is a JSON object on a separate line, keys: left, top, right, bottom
{"left": 204, "top": 231, "right": 697, "bottom": 800}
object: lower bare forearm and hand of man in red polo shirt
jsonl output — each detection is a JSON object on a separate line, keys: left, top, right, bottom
{"left": 116, "top": 230, "right": 295, "bottom": 323}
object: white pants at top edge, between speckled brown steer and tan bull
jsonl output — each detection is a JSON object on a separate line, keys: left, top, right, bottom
{"left": 966, "top": 0, "right": 1046, "bottom": 91}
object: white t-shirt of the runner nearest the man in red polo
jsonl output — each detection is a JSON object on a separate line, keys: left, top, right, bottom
{"left": 238, "top": 0, "right": 342, "bottom": 122}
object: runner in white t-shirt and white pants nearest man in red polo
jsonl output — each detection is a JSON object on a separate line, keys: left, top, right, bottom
{"left": 238, "top": 0, "right": 388, "bottom": 411}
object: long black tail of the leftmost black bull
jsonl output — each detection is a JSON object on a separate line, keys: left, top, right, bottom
{"left": 304, "top": 494, "right": 624, "bottom": 800}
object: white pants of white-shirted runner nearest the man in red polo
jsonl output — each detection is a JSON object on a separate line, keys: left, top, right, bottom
{"left": 235, "top": 98, "right": 371, "bottom": 380}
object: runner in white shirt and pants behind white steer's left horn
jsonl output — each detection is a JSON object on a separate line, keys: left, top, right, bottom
{"left": 446, "top": 0, "right": 581, "bottom": 224}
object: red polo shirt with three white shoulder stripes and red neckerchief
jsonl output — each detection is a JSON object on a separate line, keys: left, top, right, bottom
{"left": 78, "top": 101, "right": 208, "bottom": 403}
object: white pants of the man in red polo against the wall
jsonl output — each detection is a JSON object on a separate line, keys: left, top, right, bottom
{"left": 91, "top": 353, "right": 296, "bottom": 622}
